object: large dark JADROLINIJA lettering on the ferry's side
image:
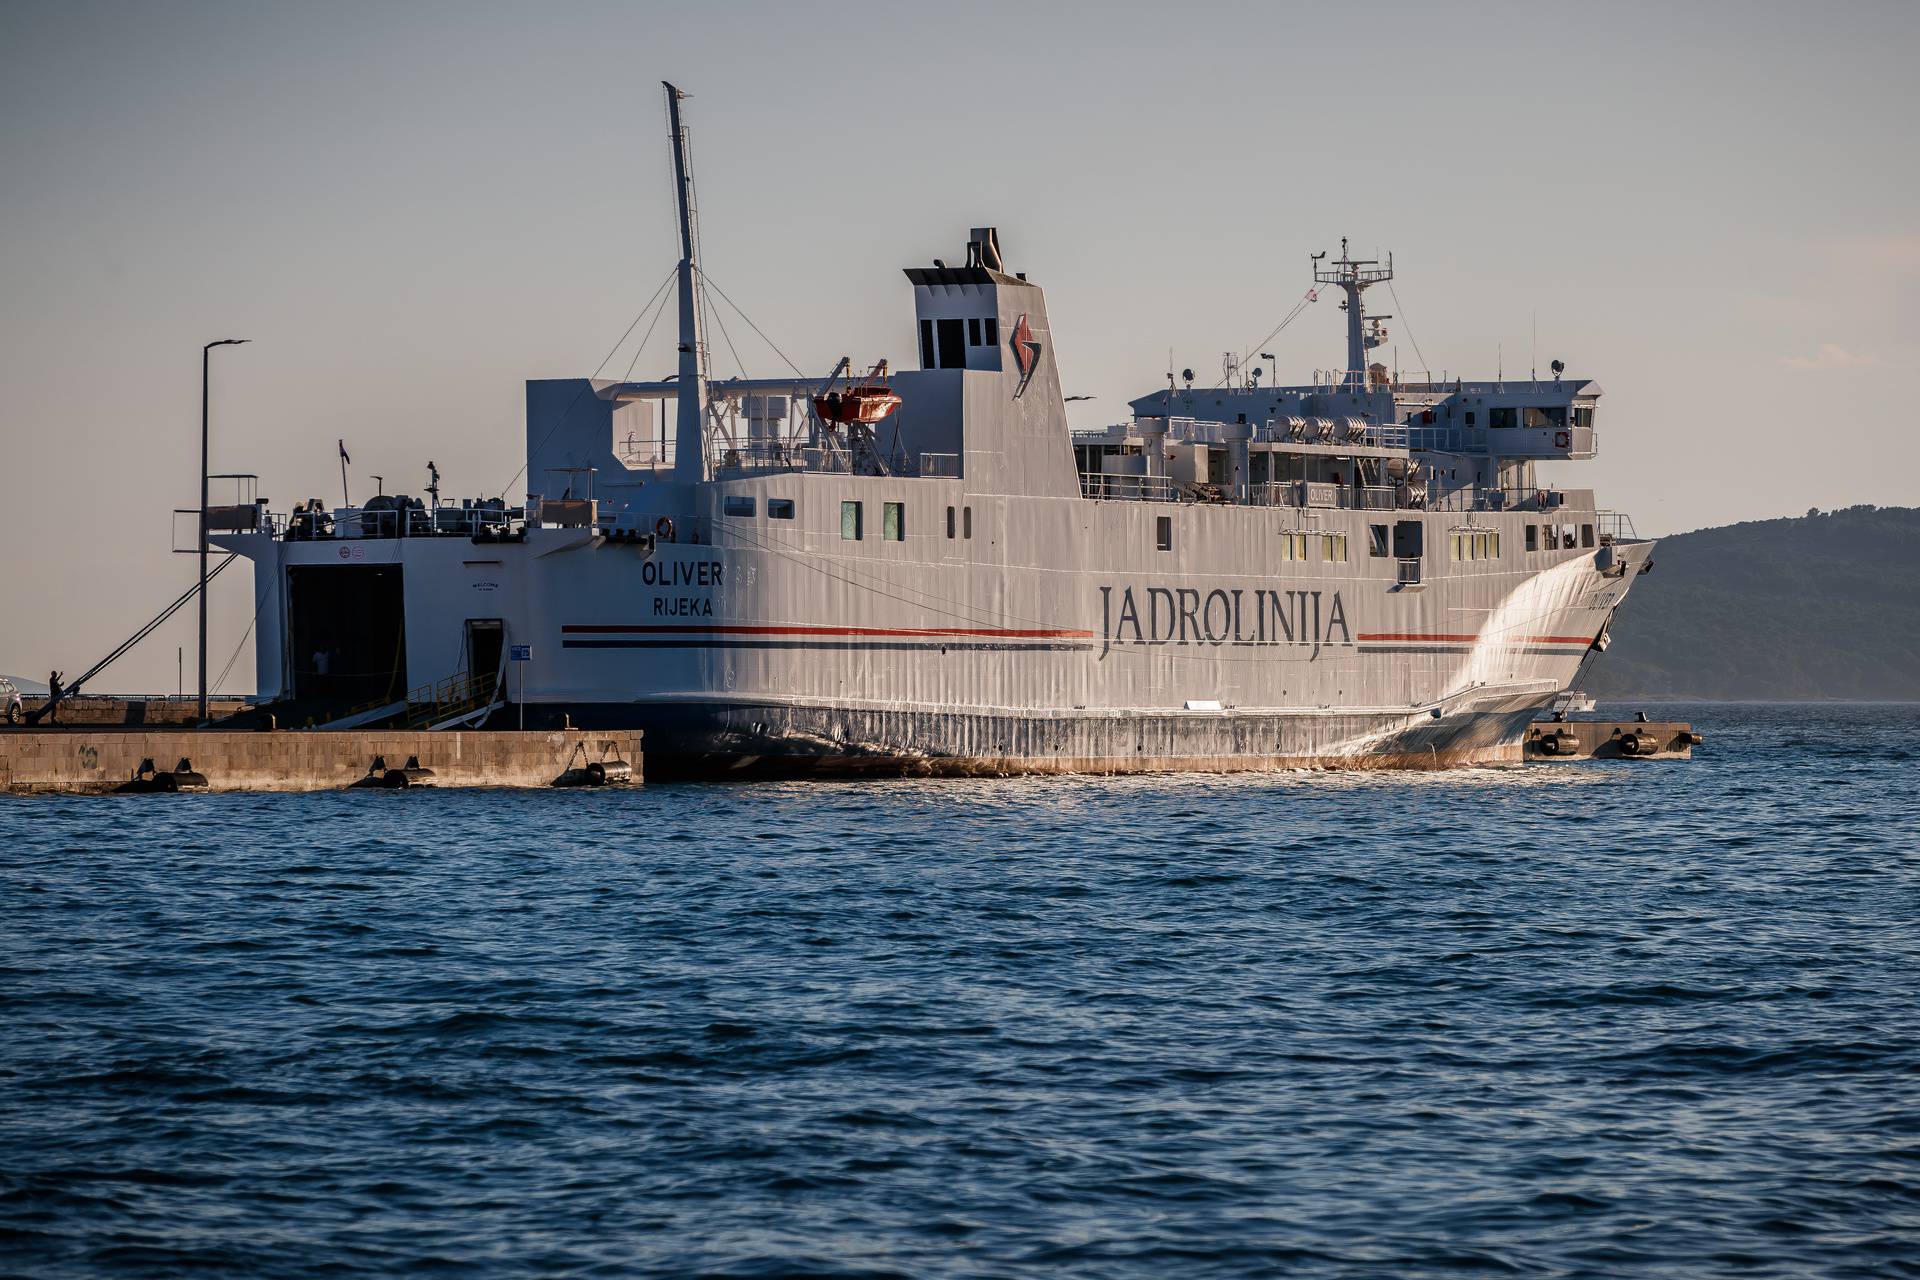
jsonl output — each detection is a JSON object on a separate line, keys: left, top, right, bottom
{"left": 1100, "top": 587, "right": 1354, "bottom": 658}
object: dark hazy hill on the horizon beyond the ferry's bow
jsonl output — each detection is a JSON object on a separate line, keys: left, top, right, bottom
{"left": 1588, "top": 507, "right": 1920, "bottom": 700}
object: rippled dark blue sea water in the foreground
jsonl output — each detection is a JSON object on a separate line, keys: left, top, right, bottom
{"left": 0, "top": 706, "right": 1920, "bottom": 1276}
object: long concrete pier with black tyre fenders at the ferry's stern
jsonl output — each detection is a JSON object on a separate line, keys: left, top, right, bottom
{"left": 0, "top": 729, "right": 641, "bottom": 794}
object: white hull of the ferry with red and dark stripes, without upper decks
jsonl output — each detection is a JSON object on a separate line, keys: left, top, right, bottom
{"left": 238, "top": 485, "right": 1651, "bottom": 773}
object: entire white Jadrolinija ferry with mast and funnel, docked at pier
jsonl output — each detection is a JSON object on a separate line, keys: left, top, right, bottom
{"left": 210, "top": 88, "right": 1651, "bottom": 773}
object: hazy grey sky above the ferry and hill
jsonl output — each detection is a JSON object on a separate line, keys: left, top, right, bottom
{"left": 0, "top": 0, "right": 1920, "bottom": 691}
